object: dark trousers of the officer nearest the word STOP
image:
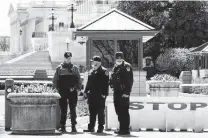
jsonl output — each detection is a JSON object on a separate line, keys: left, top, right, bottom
{"left": 114, "top": 94, "right": 130, "bottom": 131}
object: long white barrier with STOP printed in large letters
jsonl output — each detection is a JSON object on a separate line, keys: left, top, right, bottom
{"left": 107, "top": 96, "right": 208, "bottom": 132}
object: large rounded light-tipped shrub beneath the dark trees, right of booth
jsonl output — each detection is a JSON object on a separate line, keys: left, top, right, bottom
{"left": 156, "top": 48, "right": 194, "bottom": 77}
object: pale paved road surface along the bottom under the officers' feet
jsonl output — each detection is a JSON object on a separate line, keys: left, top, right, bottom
{"left": 0, "top": 132, "right": 208, "bottom": 138}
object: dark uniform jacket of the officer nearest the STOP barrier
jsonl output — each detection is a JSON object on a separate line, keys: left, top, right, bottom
{"left": 110, "top": 61, "right": 134, "bottom": 95}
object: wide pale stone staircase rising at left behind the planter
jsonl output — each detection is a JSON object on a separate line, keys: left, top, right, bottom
{"left": 0, "top": 51, "right": 60, "bottom": 76}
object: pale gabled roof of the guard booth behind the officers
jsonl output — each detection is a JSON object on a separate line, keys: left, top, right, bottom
{"left": 75, "top": 8, "right": 159, "bottom": 41}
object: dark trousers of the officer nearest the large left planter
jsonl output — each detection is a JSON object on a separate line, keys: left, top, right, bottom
{"left": 59, "top": 90, "right": 77, "bottom": 126}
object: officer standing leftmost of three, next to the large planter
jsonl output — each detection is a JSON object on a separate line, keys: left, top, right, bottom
{"left": 53, "top": 51, "right": 81, "bottom": 132}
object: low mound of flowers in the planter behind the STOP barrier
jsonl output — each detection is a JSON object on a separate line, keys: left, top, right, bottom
{"left": 151, "top": 74, "right": 178, "bottom": 81}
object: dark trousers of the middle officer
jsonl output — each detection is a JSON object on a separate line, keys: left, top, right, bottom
{"left": 88, "top": 94, "right": 105, "bottom": 129}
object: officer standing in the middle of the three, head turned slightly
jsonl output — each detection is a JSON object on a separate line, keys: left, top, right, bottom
{"left": 84, "top": 56, "right": 109, "bottom": 133}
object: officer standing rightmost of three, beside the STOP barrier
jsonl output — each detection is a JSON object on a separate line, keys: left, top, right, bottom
{"left": 110, "top": 52, "right": 133, "bottom": 135}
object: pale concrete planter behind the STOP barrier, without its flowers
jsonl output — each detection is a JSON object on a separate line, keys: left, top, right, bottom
{"left": 149, "top": 81, "right": 181, "bottom": 97}
